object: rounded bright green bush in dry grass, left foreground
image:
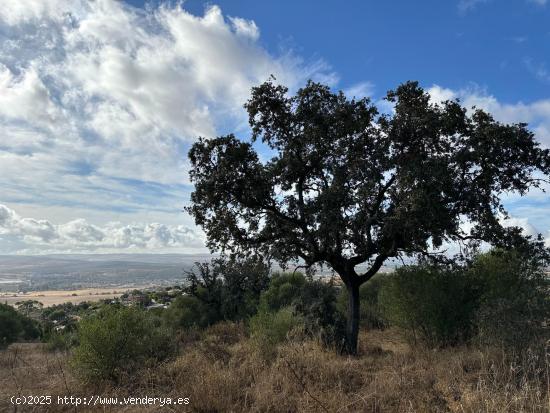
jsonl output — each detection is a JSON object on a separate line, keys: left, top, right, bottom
{"left": 72, "top": 306, "right": 173, "bottom": 382}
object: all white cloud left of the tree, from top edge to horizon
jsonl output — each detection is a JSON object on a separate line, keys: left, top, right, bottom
{"left": 0, "top": 0, "right": 338, "bottom": 249}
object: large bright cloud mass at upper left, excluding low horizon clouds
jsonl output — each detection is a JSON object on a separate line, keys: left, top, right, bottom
{"left": 0, "top": 0, "right": 335, "bottom": 184}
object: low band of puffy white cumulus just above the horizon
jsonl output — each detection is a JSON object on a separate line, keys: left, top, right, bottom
{"left": 0, "top": 204, "right": 204, "bottom": 253}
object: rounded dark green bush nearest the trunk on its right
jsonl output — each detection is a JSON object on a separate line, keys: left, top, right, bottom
{"left": 379, "top": 265, "right": 479, "bottom": 347}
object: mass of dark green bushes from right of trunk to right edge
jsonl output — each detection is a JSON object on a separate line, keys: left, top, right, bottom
{"left": 379, "top": 250, "right": 550, "bottom": 353}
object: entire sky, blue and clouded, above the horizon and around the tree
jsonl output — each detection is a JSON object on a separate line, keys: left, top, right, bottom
{"left": 0, "top": 0, "right": 550, "bottom": 254}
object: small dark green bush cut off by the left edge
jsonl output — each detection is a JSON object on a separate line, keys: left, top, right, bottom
{"left": 0, "top": 304, "right": 40, "bottom": 348}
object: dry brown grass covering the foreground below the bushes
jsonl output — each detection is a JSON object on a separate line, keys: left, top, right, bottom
{"left": 0, "top": 324, "right": 550, "bottom": 413}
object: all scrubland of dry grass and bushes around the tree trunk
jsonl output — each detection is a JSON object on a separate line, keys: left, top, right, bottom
{"left": 0, "top": 246, "right": 550, "bottom": 412}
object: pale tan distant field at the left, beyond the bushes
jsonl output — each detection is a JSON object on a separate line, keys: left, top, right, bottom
{"left": 0, "top": 286, "right": 142, "bottom": 307}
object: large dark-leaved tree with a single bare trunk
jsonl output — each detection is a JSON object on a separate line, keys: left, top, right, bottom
{"left": 187, "top": 80, "right": 550, "bottom": 354}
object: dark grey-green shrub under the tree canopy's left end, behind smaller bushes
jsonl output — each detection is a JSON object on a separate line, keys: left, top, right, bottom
{"left": 186, "top": 257, "right": 269, "bottom": 325}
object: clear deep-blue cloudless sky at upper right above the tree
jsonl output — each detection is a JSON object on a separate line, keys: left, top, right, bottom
{"left": 129, "top": 0, "right": 550, "bottom": 102}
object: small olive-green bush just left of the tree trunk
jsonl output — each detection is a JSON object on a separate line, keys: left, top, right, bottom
{"left": 250, "top": 307, "right": 304, "bottom": 357}
